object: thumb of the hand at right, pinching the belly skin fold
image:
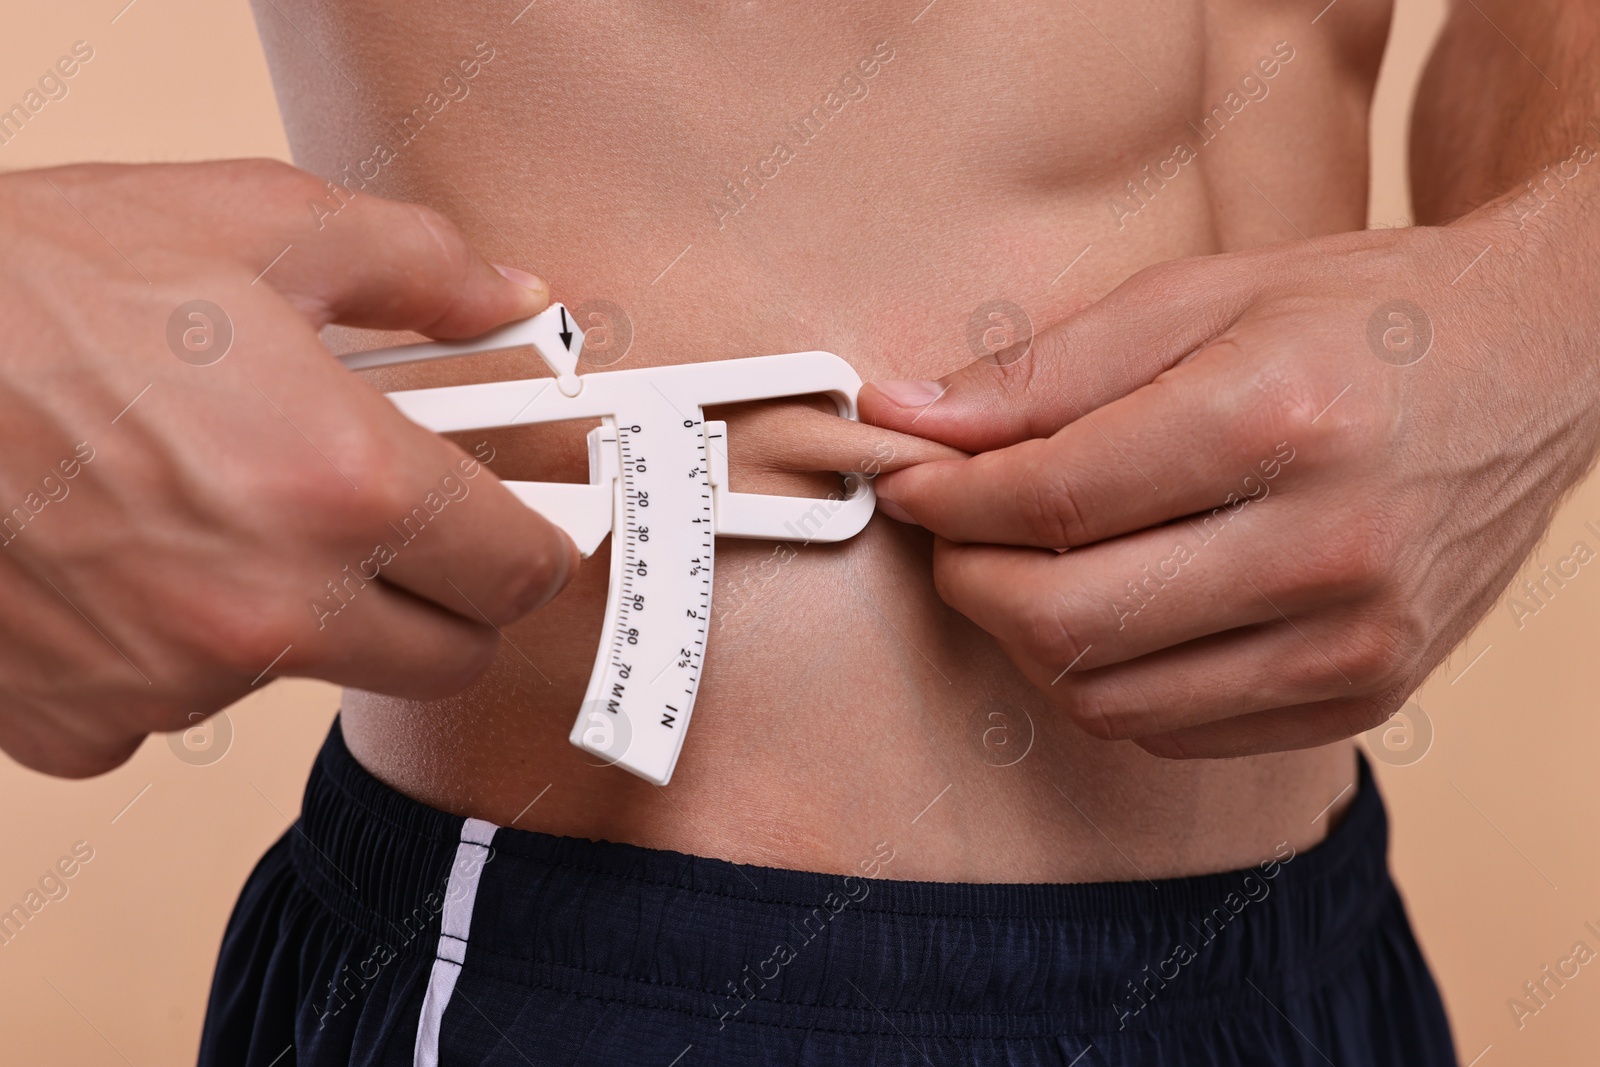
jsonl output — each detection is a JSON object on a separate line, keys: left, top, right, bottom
{"left": 859, "top": 256, "right": 1254, "bottom": 453}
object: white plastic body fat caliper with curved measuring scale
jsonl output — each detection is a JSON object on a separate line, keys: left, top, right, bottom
{"left": 341, "top": 304, "right": 874, "bottom": 785}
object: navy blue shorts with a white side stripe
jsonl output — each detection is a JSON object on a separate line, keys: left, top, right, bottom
{"left": 200, "top": 725, "right": 1456, "bottom": 1067}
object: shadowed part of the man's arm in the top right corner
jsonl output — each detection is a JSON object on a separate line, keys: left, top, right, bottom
{"left": 1411, "top": 0, "right": 1600, "bottom": 224}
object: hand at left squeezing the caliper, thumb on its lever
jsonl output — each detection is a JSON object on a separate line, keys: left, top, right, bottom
{"left": 0, "top": 162, "right": 578, "bottom": 776}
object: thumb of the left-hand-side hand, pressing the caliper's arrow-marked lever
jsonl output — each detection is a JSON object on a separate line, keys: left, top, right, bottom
{"left": 266, "top": 183, "right": 550, "bottom": 338}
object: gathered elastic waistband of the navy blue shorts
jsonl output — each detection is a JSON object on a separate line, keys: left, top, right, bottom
{"left": 291, "top": 723, "right": 1398, "bottom": 1037}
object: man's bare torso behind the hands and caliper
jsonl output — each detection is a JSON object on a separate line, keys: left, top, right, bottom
{"left": 258, "top": 0, "right": 1389, "bottom": 881}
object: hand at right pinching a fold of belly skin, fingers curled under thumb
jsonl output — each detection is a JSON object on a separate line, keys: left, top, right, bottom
{"left": 861, "top": 220, "right": 1600, "bottom": 757}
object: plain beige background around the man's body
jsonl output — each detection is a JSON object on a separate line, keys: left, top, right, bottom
{"left": 0, "top": 0, "right": 1600, "bottom": 1067}
